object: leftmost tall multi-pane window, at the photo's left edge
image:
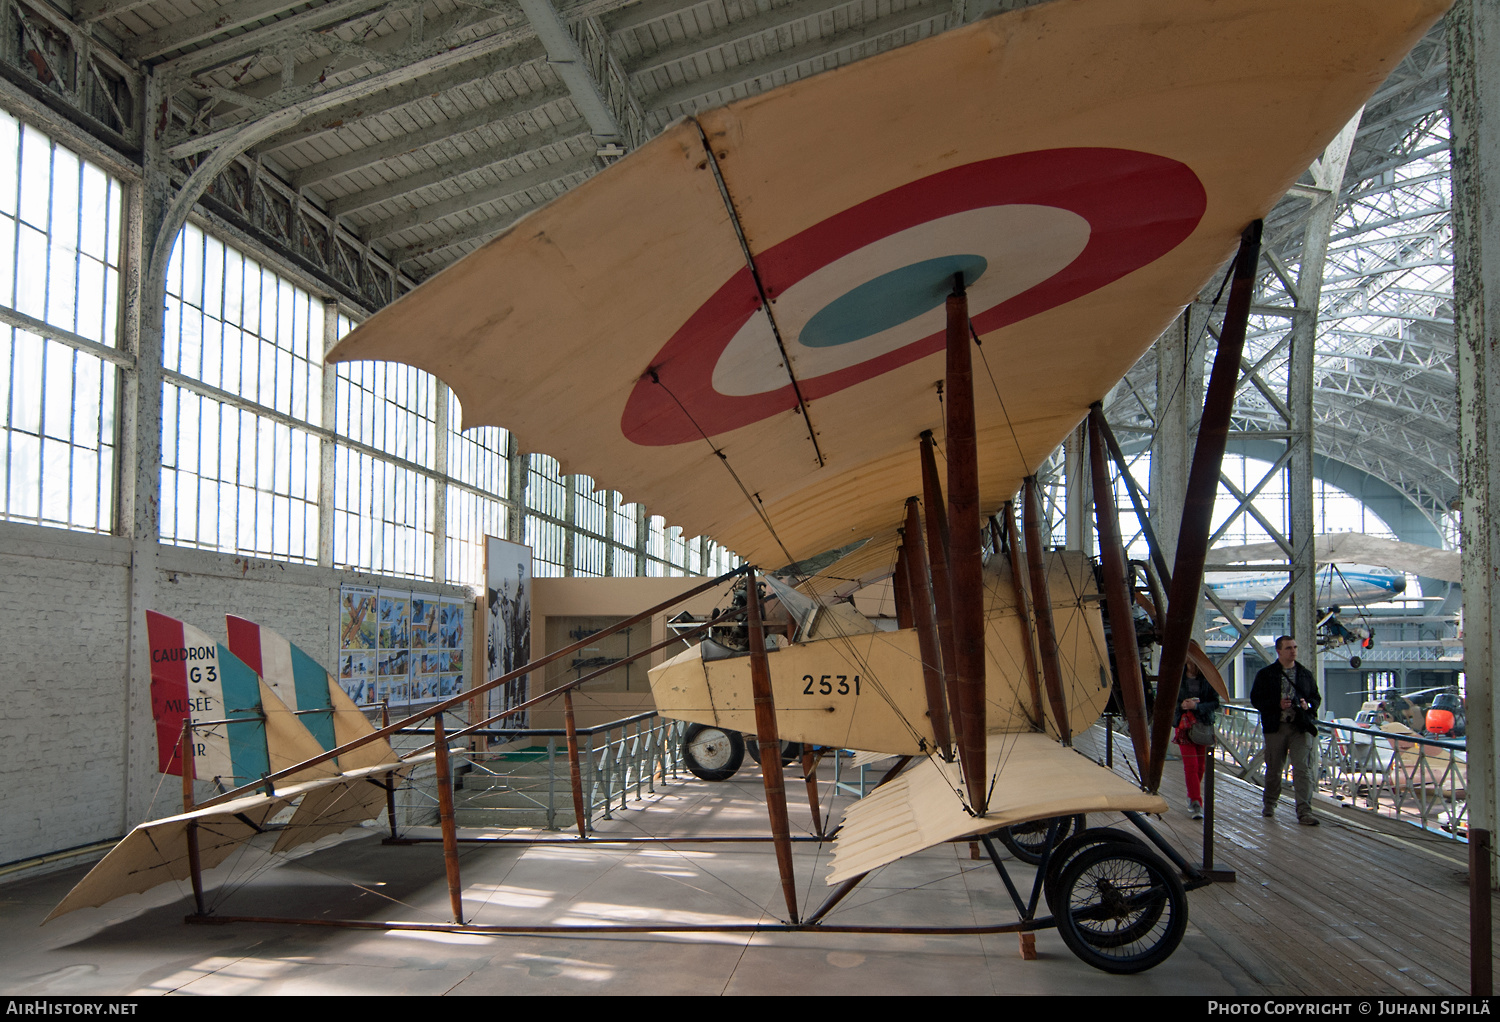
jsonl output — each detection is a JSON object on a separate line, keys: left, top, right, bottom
{"left": 0, "top": 111, "right": 122, "bottom": 533}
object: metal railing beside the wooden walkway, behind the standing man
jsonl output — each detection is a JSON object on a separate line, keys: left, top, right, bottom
{"left": 1214, "top": 705, "right": 1469, "bottom": 840}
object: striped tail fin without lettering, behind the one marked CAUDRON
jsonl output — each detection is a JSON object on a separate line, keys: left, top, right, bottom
{"left": 225, "top": 614, "right": 396, "bottom": 770}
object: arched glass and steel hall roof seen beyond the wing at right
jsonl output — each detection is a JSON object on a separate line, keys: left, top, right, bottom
{"left": 1106, "top": 26, "right": 1460, "bottom": 545}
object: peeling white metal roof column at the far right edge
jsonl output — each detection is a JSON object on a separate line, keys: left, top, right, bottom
{"left": 1448, "top": 0, "right": 1500, "bottom": 876}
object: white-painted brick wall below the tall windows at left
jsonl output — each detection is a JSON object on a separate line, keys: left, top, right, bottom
{"left": 0, "top": 522, "right": 474, "bottom": 864}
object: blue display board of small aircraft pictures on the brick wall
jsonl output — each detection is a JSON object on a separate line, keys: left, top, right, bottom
{"left": 339, "top": 585, "right": 468, "bottom": 707}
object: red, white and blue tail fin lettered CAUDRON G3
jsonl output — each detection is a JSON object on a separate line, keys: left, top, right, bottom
{"left": 146, "top": 611, "right": 338, "bottom": 786}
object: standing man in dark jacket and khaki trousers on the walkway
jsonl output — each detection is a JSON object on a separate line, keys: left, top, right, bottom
{"left": 1250, "top": 635, "right": 1323, "bottom": 827}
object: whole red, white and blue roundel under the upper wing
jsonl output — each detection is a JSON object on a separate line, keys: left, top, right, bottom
{"left": 621, "top": 149, "right": 1206, "bottom": 446}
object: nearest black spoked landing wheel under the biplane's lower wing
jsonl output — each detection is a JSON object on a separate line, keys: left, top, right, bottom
{"left": 1053, "top": 842, "right": 1188, "bottom": 972}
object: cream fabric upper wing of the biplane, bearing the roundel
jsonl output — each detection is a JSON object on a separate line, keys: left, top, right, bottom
{"left": 330, "top": 0, "right": 1448, "bottom": 564}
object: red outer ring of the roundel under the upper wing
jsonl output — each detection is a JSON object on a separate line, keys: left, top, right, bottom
{"left": 620, "top": 149, "right": 1208, "bottom": 447}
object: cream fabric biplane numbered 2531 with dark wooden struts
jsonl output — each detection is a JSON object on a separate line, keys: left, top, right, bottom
{"left": 49, "top": 0, "right": 1448, "bottom": 971}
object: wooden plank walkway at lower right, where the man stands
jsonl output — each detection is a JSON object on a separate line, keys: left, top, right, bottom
{"left": 1079, "top": 729, "right": 1493, "bottom": 996}
